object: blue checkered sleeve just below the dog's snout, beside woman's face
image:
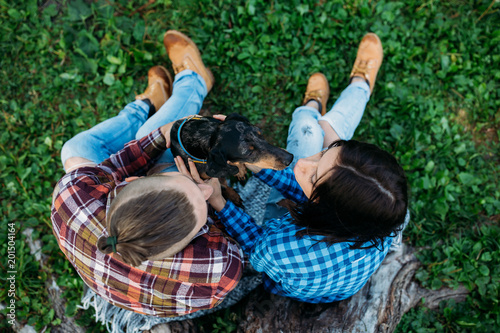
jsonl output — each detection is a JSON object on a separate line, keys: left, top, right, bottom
{"left": 255, "top": 168, "right": 307, "bottom": 203}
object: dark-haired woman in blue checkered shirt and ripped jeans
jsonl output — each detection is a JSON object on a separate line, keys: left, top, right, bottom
{"left": 180, "top": 33, "right": 408, "bottom": 303}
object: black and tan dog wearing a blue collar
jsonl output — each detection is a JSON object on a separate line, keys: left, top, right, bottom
{"left": 170, "top": 113, "right": 293, "bottom": 178}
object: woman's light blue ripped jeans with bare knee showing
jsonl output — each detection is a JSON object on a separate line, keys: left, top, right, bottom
{"left": 264, "top": 81, "right": 370, "bottom": 221}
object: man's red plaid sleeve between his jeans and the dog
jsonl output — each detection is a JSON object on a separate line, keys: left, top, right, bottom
{"left": 98, "top": 128, "right": 167, "bottom": 179}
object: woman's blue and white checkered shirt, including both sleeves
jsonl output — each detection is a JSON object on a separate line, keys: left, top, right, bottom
{"left": 217, "top": 169, "right": 392, "bottom": 303}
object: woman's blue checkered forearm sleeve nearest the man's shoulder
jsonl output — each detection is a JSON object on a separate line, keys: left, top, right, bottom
{"left": 216, "top": 201, "right": 264, "bottom": 254}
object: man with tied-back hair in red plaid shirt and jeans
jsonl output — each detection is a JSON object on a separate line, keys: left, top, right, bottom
{"left": 51, "top": 31, "right": 243, "bottom": 317}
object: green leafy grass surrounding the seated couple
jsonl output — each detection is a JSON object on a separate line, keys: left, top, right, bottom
{"left": 0, "top": 0, "right": 500, "bottom": 332}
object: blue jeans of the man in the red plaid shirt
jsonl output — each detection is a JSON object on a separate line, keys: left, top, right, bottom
{"left": 61, "top": 70, "right": 207, "bottom": 171}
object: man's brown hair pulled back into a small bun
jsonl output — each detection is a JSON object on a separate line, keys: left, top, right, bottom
{"left": 97, "top": 176, "right": 196, "bottom": 266}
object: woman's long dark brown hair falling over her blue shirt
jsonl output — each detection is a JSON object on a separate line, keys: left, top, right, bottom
{"left": 291, "top": 140, "right": 408, "bottom": 248}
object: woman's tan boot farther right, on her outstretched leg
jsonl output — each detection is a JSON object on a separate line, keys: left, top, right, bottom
{"left": 350, "top": 32, "right": 384, "bottom": 94}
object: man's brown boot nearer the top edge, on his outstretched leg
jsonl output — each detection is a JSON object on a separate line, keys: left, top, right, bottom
{"left": 163, "top": 30, "right": 215, "bottom": 92}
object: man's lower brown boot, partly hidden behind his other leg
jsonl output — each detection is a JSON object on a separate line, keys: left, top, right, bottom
{"left": 135, "top": 66, "right": 172, "bottom": 110}
